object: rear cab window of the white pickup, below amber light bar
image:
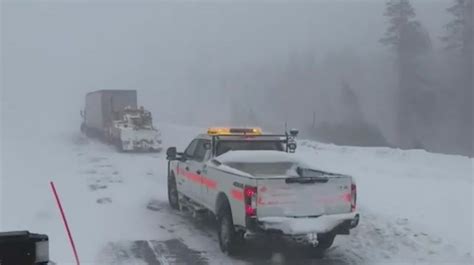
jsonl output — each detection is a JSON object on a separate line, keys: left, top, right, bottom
{"left": 216, "top": 140, "right": 285, "bottom": 156}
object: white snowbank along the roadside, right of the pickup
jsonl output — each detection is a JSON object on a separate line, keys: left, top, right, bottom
{"left": 297, "top": 141, "right": 474, "bottom": 257}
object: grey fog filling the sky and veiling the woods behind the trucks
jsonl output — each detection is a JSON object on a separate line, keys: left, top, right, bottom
{"left": 1, "top": 0, "right": 472, "bottom": 154}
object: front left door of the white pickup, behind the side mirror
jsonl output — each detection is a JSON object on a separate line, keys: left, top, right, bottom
{"left": 176, "top": 139, "right": 198, "bottom": 198}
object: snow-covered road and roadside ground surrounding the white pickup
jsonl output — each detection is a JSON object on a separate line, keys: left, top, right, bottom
{"left": 0, "top": 124, "right": 474, "bottom": 264}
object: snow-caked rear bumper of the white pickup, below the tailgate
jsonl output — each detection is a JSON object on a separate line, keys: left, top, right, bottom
{"left": 247, "top": 213, "right": 359, "bottom": 237}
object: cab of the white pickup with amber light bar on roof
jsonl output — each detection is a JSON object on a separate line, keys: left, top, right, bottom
{"left": 168, "top": 128, "right": 297, "bottom": 204}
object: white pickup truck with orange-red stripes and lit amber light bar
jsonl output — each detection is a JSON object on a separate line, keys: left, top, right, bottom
{"left": 167, "top": 128, "right": 359, "bottom": 255}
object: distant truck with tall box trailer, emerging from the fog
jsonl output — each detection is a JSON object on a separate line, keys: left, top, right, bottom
{"left": 81, "top": 90, "right": 162, "bottom": 152}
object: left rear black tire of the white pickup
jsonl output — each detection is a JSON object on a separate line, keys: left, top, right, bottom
{"left": 217, "top": 201, "right": 243, "bottom": 256}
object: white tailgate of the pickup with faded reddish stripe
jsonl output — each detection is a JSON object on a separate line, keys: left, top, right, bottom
{"left": 257, "top": 175, "right": 352, "bottom": 219}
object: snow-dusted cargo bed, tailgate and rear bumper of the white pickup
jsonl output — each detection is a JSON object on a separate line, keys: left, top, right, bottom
{"left": 216, "top": 151, "right": 358, "bottom": 235}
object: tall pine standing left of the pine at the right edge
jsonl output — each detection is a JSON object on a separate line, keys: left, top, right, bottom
{"left": 380, "top": 0, "right": 432, "bottom": 148}
